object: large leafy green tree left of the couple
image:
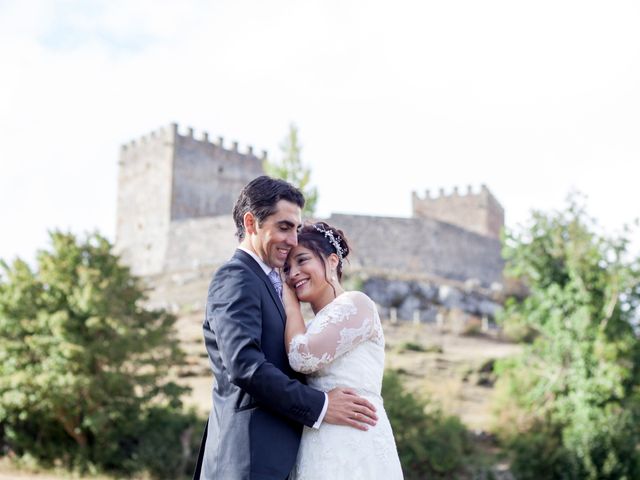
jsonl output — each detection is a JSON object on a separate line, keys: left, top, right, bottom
{"left": 0, "top": 232, "right": 190, "bottom": 471}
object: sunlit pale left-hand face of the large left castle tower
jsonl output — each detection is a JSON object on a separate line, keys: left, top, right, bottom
{"left": 116, "top": 129, "right": 174, "bottom": 275}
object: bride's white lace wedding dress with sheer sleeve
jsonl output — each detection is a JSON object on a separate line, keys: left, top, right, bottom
{"left": 289, "top": 292, "right": 402, "bottom": 480}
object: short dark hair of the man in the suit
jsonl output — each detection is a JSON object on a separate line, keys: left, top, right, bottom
{"left": 233, "top": 175, "right": 304, "bottom": 241}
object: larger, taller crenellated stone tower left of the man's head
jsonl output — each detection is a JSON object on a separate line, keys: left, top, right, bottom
{"left": 116, "top": 124, "right": 266, "bottom": 275}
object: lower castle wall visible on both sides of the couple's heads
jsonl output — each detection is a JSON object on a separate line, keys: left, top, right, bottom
{"left": 156, "top": 214, "right": 504, "bottom": 288}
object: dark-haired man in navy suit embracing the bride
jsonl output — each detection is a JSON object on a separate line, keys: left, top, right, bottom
{"left": 194, "top": 176, "right": 377, "bottom": 480}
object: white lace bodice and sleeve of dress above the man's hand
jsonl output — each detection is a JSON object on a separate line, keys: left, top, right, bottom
{"left": 289, "top": 291, "right": 384, "bottom": 395}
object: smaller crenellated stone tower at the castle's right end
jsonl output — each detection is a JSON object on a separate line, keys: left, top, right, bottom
{"left": 411, "top": 185, "right": 504, "bottom": 239}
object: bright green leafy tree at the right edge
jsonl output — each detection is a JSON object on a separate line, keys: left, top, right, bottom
{"left": 497, "top": 195, "right": 640, "bottom": 480}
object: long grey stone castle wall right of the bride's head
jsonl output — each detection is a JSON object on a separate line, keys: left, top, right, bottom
{"left": 327, "top": 214, "right": 504, "bottom": 287}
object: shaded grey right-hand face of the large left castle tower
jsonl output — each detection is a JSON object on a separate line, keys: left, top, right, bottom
{"left": 171, "top": 130, "right": 264, "bottom": 220}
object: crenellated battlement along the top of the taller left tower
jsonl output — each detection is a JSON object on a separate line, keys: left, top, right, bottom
{"left": 120, "top": 123, "right": 268, "bottom": 161}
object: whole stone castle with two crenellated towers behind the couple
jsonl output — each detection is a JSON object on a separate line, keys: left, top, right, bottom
{"left": 116, "top": 124, "right": 504, "bottom": 321}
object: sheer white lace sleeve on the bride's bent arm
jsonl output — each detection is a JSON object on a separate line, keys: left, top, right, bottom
{"left": 289, "top": 292, "right": 376, "bottom": 373}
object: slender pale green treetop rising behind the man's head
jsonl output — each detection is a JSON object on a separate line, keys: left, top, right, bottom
{"left": 263, "top": 123, "right": 318, "bottom": 217}
